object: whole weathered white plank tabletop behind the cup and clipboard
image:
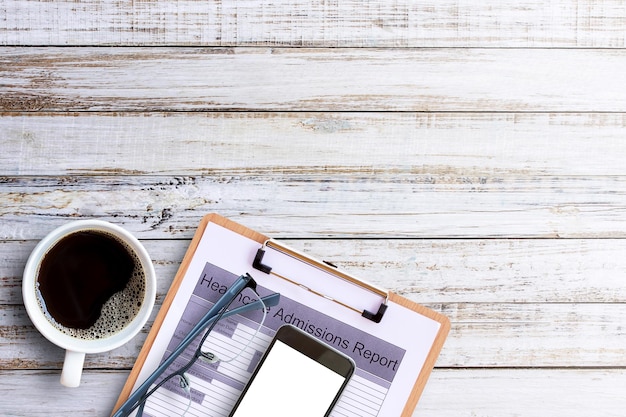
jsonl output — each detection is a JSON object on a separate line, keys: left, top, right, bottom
{"left": 0, "top": 0, "right": 626, "bottom": 417}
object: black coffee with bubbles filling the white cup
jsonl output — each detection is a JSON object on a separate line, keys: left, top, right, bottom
{"left": 36, "top": 230, "right": 145, "bottom": 339}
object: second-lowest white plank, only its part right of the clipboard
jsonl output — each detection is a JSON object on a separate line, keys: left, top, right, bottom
{"left": 438, "top": 303, "right": 626, "bottom": 368}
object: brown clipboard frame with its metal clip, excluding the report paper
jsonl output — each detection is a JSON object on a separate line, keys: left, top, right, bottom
{"left": 114, "top": 214, "right": 450, "bottom": 417}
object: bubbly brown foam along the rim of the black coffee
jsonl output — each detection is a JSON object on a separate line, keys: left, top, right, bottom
{"left": 35, "top": 230, "right": 146, "bottom": 340}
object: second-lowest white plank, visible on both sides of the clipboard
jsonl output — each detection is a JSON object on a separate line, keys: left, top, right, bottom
{"left": 0, "top": 303, "right": 626, "bottom": 369}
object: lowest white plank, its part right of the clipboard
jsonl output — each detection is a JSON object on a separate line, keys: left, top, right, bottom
{"left": 413, "top": 369, "right": 626, "bottom": 417}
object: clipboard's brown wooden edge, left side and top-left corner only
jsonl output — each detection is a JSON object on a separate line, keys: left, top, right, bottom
{"left": 111, "top": 213, "right": 268, "bottom": 414}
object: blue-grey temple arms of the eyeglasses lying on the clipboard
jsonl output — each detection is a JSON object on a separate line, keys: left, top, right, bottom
{"left": 112, "top": 274, "right": 280, "bottom": 417}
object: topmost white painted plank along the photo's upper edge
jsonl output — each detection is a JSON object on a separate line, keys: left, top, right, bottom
{"left": 0, "top": 0, "right": 626, "bottom": 48}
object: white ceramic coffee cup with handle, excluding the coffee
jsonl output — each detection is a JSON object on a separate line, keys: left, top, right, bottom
{"left": 22, "top": 220, "right": 156, "bottom": 387}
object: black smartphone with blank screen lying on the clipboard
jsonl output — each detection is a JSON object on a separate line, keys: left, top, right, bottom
{"left": 229, "top": 325, "right": 354, "bottom": 417}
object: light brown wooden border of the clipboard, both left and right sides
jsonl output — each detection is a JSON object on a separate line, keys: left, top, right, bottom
{"left": 113, "top": 213, "right": 450, "bottom": 417}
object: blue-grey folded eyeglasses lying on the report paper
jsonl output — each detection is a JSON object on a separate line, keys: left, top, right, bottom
{"left": 112, "top": 274, "right": 280, "bottom": 417}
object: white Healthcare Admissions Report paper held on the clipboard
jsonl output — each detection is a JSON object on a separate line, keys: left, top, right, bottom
{"left": 129, "top": 223, "right": 441, "bottom": 417}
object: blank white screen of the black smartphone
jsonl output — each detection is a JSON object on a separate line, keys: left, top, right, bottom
{"left": 233, "top": 340, "right": 344, "bottom": 417}
